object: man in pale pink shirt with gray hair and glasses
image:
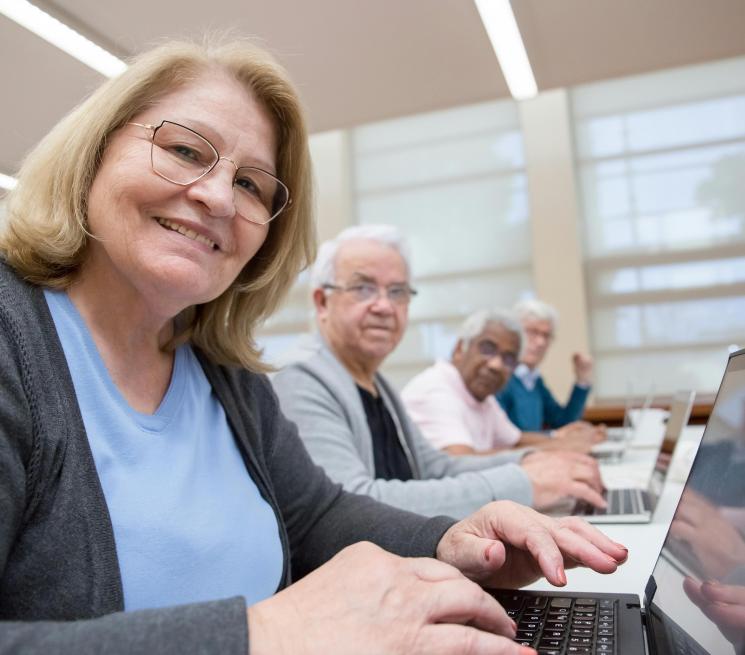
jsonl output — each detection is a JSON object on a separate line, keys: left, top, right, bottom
{"left": 401, "top": 310, "right": 604, "bottom": 455}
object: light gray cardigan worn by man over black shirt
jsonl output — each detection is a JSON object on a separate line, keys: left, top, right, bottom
{"left": 272, "top": 339, "right": 532, "bottom": 518}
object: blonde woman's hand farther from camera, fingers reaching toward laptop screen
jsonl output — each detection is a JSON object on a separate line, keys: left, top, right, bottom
{"left": 437, "top": 500, "right": 628, "bottom": 589}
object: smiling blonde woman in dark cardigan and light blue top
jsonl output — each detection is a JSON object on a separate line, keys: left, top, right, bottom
{"left": 0, "top": 37, "right": 625, "bottom": 655}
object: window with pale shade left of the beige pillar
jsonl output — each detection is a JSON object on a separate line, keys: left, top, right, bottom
{"left": 352, "top": 101, "right": 531, "bottom": 386}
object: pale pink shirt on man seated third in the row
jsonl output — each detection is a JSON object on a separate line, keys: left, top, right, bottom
{"left": 401, "top": 361, "right": 522, "bottom": 451}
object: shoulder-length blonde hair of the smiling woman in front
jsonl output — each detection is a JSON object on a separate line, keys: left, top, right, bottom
{"left": 0, "top": 41, "right": 316, "bottom": 371}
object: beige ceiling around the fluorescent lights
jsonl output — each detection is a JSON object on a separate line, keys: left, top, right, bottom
{"left": 0, "top": 0, "right": 745, "bottom": 173}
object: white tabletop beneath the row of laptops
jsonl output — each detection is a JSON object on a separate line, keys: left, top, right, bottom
{"left": 527, "top": 425, "right": 704, "bottom": 598}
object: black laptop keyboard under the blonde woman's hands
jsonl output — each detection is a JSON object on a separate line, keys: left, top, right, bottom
{"left": 494, "top": 591, "right": 617, "bottom": 655}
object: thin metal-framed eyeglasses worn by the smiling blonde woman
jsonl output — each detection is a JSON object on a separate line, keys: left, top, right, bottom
{"left": 129, "top": 121, "right": 291, "bottom": 225}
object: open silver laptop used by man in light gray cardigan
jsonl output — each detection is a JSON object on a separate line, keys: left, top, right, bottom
{"left": 572, "top": 391, "right": 696, "bottom": 523}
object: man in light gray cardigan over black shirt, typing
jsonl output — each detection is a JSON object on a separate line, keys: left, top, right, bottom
{"left": 273, "top": 226, "right": 605, "bottom": 517}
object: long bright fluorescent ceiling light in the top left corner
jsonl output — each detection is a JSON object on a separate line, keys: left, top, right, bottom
{"left": 0, "top": 0, "right": 127, "bottom": 77}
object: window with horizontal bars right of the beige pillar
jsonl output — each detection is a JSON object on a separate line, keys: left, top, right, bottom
{"left": 571, "top": 58, "right": 745, "bottom": 397}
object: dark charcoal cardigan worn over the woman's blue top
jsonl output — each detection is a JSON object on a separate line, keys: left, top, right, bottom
{"left": 0, "top": 263, "right": 453, "bottom": 655}
